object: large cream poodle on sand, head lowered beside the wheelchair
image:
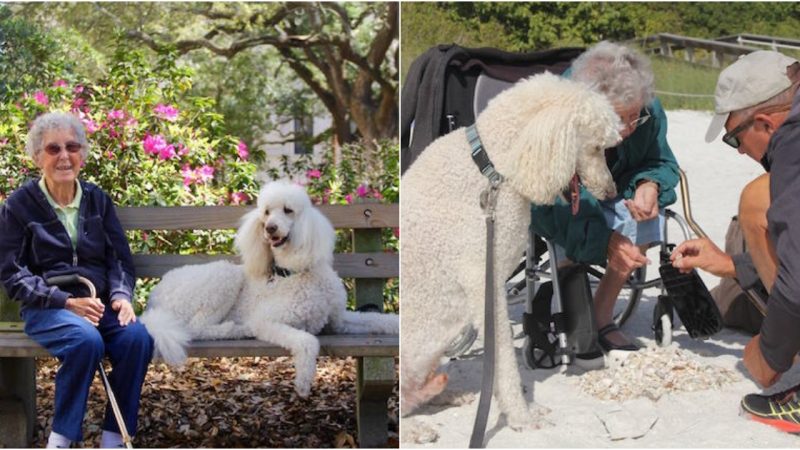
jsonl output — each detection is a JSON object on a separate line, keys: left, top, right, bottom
{"left": 400, "top": 73, "right": 620, "bottom": 428}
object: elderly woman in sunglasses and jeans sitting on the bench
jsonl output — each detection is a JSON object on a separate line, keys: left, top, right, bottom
{"left": 0, "top": 113, "right": 153, "bottom": 448}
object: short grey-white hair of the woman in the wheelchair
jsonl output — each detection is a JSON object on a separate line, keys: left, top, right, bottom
{"left": 572, "top": 41, "right": 655, "bottom": 105}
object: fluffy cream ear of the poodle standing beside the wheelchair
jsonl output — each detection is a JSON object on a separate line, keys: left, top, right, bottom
{"left": 503, "top": 103, "right": 581, "bottom": 205}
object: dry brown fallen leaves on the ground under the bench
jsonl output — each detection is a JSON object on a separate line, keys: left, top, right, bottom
{"left": 33, "top": 357, "right": 398, "bottom": 448}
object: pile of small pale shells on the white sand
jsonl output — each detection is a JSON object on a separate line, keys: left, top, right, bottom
{"left": 580, "top": 347, "right": 742, "bottom": 401}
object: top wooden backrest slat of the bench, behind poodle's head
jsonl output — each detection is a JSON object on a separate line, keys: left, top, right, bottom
{"left": 117, "top": 203, "right": 400, "bottom": 230}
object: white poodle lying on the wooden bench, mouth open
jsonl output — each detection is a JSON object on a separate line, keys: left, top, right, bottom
{"left": 142, "top": 181, "right": 399, "bottom": 396}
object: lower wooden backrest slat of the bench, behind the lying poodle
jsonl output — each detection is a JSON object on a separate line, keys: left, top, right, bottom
{"left": 133, "top": 253, "right": 400, "bottom": 278}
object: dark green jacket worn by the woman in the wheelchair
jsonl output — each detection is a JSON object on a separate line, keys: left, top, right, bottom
{"left": 531, "top": 95, "right": 678, "bottom": 264}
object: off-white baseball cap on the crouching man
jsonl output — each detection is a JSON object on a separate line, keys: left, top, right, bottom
{"left": 706, "top": 50, "right": 798, "bottom": 142}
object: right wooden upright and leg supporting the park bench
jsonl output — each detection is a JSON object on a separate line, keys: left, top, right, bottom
{"left": 353, "top": 203, "right": 396, "bottom": 448}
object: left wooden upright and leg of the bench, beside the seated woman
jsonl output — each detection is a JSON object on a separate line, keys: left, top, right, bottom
{"left": 0, "top": 288, "right": 36, "bottom": 448}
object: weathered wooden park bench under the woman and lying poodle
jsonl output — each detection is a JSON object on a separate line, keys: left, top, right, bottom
{"left": 0, "top": 203, "right": 399, "bottom": 447}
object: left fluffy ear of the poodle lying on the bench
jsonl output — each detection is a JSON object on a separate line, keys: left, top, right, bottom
{"left": 234, "top": 208, "right": 272, "bottom": 278}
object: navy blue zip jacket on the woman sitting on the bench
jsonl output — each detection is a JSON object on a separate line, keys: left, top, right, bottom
{"left": 0, "top": 179, "right": 136, "bottom": 309}
